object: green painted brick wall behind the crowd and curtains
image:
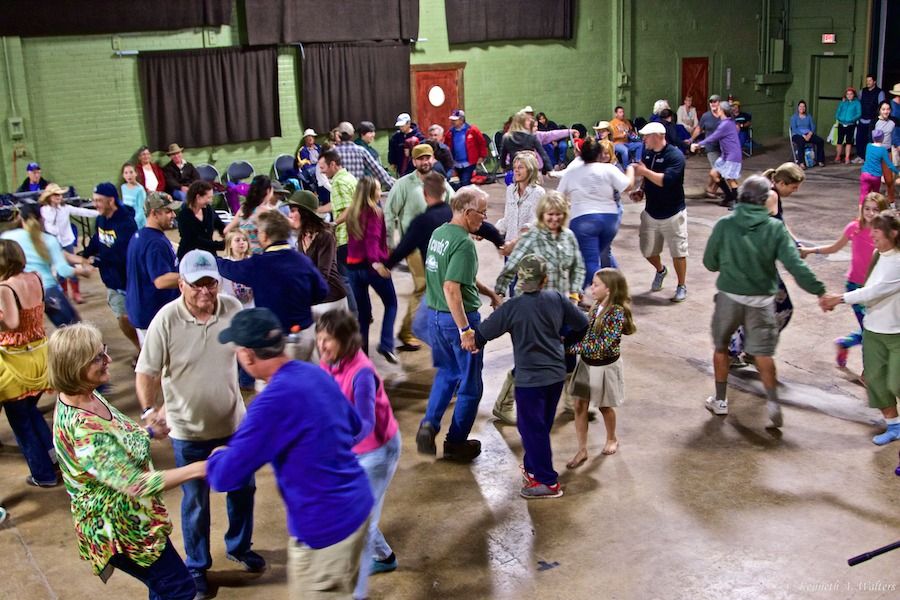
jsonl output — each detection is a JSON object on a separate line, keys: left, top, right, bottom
{"left": 0, "top": 0, "right": 866, "bottom": 194}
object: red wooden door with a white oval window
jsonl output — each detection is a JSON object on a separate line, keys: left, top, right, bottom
{"left": 410, "top": 64, "right": 464, "bottom": 134}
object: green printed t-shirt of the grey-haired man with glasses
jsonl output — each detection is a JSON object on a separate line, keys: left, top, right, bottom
{"left": 425, "top": 223, "right": 481, "bottom": 313}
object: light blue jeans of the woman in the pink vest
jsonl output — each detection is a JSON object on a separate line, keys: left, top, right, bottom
{"left": 353, "top": 429, "right": 402, "bottom": 598}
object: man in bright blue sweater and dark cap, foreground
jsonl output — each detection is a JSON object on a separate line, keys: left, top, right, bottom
{"left": 206, "top": 308, "right": 374, "bottom": 598}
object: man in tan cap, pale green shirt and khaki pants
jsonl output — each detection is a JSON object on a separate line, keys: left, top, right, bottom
{"left": 384, "top": 144, "right": 453, "bottom": 352}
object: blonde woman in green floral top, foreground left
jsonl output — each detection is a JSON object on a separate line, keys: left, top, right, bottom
{"left": 48, "top": 323, "right": 206, "bottom": 600}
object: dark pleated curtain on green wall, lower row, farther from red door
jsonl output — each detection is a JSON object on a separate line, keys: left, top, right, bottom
{"left": 138, "top": 47, "right": 281, "bottom": 149}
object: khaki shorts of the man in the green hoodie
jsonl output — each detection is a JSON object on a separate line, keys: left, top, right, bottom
{"left": 712, "top": 292, "right": 778, "bottom": 356}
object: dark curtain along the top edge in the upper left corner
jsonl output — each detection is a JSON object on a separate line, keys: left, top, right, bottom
{"left": 0, "top": 0, "right": 232, "bottom": 37}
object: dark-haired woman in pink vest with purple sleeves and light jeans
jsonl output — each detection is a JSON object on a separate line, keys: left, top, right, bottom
{"left": 316, "top": 310, "right": 401, "bottom": 598}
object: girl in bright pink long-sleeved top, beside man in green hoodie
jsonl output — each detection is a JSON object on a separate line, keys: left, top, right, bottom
{"left": 800, "top": 192, "right": 890, "bottom": 368}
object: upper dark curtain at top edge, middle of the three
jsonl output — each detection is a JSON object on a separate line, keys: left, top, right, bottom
{"left": 244, "top": 0, "right": 419, "bottom": 46}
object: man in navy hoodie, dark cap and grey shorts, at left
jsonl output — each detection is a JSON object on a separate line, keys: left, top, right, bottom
{"left": 82, "top": 182, "right": 141, "bottom": 352}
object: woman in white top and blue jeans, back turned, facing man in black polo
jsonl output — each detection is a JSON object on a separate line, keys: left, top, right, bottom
{"left": 558, "top": 137, "right": 634, "bottom": 287}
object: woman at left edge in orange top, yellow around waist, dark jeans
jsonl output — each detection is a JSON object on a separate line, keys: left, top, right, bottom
{"left": 0, "top": 237, "right": 59, "bottom": 487}
